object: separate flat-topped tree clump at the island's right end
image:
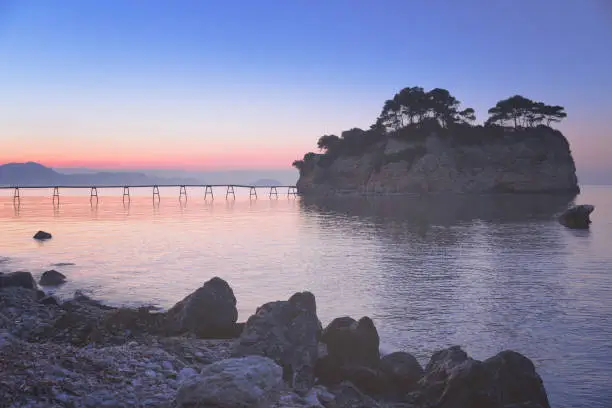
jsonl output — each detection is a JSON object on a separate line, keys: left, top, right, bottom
{"left": 485, "top": 95, "right": 567, "bottom": 128}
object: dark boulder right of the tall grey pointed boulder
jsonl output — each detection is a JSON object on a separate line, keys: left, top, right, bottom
{"left": 316, "top": 316, "right": 385, "bottom": 394}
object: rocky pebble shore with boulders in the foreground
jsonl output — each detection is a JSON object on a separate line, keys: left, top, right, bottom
{"left": 0, "top": 272, "right": 549, "bottom": 408}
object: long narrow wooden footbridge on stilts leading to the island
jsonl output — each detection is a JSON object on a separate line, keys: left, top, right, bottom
{"left": 0, "top": 184, "right": 297, "bottom": 203}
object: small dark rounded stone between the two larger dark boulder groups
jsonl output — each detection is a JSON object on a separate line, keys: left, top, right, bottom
{"left": 380, "top": 351, "right": 425, "bottom": 395}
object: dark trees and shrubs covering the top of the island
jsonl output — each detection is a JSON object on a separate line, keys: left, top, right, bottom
{"left": 293, "top": 87, "right": 567, "bottom": 172}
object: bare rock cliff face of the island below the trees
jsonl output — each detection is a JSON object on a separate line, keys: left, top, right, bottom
{"left": 297, "top": 127, "right": 579, "bottom": 195}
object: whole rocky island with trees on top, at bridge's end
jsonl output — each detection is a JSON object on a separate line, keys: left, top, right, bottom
{"left": 293, "top": 87, "right": 579, "bottom": 195}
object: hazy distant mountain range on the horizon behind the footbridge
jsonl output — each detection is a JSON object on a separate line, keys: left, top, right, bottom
{"left": 0, "top": 162, "right": 198, "bottom": 187}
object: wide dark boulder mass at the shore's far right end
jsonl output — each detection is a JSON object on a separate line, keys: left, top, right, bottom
{"left": 419, "top": 346, "right": 550, "bottom": 408}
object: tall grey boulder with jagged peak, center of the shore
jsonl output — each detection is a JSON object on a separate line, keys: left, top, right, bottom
{"left": 233, "top": 292, "right": 321, "bottom": 393}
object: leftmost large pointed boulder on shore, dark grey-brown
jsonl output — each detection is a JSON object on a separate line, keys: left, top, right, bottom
{"left": 166, "top": 277, "right": 238, "bottom": 338}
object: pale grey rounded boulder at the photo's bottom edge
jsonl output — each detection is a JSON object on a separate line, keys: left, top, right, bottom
{"left": 176, "top": 356, "right": 284, "bottom": 408}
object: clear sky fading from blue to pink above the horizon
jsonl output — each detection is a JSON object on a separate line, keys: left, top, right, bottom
{"left": 0, "top": 0, "right": 612, "bottom": 175}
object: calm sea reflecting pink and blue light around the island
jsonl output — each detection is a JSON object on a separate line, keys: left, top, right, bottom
{"left": 0, "top": 186, "right": 612, "bottom": 408}
